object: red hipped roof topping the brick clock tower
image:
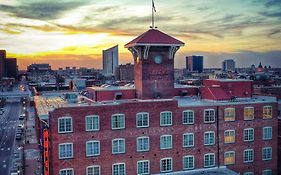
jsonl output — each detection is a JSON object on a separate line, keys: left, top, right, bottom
{"left": 125, "top": 29, "right": 184, "bottom": 48}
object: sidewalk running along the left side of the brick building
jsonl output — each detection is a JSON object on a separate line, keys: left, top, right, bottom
{"left": 24, "top": 108, "right": 42, "bottom": 175}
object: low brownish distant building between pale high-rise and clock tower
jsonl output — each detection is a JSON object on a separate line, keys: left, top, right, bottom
{"left": 115, "top": 63, "right": 134, "bottom": 81}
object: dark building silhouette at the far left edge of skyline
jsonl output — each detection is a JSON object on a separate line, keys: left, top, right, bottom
{"left": 0, "top": 50, "right": 18, "bottom": 79}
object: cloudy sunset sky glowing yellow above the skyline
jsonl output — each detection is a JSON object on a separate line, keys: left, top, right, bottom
{"left": 0, "top": 0, "right": 281, "bottom": 69}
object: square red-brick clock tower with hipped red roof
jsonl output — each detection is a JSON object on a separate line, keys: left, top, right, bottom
{"left": 125, "top": 29, "right": 184, "bottom": 99}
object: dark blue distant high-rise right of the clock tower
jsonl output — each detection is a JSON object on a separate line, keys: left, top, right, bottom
{"left": 186, "top": 55, "right": 203, "bottom": 73}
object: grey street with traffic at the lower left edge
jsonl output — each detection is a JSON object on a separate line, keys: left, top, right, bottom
{"left": 0, "top": 102, "right": 21, "bottom": 175}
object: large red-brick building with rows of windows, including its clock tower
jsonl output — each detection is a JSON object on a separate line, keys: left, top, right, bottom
{"left": 35, "top": 29, "right": 278, "bottom": 175}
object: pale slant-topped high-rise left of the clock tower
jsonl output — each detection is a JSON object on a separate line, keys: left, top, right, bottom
{"left": 102, "top": 45, "right": 118, "bottom": 76}
